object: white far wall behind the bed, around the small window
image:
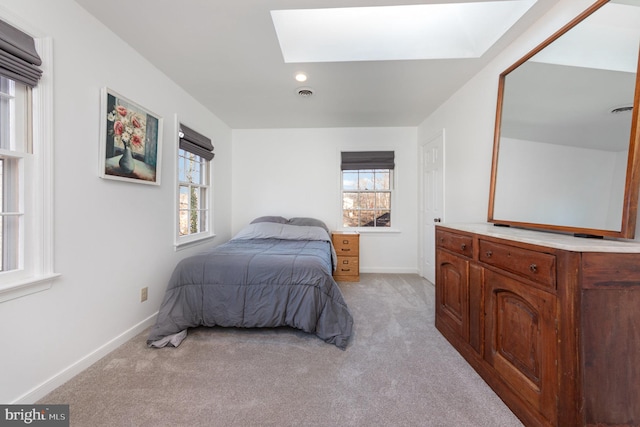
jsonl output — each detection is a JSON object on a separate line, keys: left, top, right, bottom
{"left": 232, "top": 127, "right": 418, "bottom": 273}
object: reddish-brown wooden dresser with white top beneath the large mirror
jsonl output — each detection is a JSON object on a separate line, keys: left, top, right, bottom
{"left": 436, "top": 224, "right": 640, "bottom": 427}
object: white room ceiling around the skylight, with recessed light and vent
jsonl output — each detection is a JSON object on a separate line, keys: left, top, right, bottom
{"left": 71, "top": 0, "right": 558, "bottom": 129}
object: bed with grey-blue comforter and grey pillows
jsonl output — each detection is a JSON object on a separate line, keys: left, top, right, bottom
{"left": 147, "top": 217, "right": 353, "bottom": 350}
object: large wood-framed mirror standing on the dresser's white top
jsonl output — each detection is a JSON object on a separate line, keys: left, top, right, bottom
{"left": 489, "top": 0, "right": 640, "bottom": 238}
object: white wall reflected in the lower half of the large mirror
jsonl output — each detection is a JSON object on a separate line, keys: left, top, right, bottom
{"left": 493, "top": 137, "right": 627, "bottom": 230}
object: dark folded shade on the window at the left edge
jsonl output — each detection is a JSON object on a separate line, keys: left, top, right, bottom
{"left": 0, "top": 21, "right": 42, "bottom": 87}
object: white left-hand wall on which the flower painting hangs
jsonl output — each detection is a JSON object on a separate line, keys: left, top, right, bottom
{"left": 0, "top": 0, "right": 231, "bottom": 403}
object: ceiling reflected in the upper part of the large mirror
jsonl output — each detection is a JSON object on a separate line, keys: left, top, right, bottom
{"left": 501, "top": 0, "right": 640, "bottom": 151}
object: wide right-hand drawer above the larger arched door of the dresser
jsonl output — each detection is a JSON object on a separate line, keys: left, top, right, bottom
{"left": 478, "top": 240, "right": 556, "bottom": 289}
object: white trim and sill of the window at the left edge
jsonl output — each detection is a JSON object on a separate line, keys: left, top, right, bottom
{"left": 0, "top": 38, "right": 60, "bottom": 303}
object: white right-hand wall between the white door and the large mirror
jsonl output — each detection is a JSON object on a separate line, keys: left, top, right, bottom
{"left": 418, "top": 0, "right": 593, "bottom": 227}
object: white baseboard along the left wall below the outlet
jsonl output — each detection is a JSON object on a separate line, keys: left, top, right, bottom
{"left": 11, "top": 312, "right": 158, "bottom": 405}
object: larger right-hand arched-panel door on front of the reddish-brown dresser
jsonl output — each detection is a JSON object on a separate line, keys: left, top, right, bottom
{"left": 484, "top": 270, "right": 558, "bottom": 423}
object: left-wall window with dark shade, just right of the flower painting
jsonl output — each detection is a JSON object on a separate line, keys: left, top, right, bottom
{"left": 176, "top": 125, "right": 214, "bottom": 245}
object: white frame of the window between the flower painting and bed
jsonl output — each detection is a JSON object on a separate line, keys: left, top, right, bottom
{"left": 174, "top": 115, "right": 215, "bottom": 251}
